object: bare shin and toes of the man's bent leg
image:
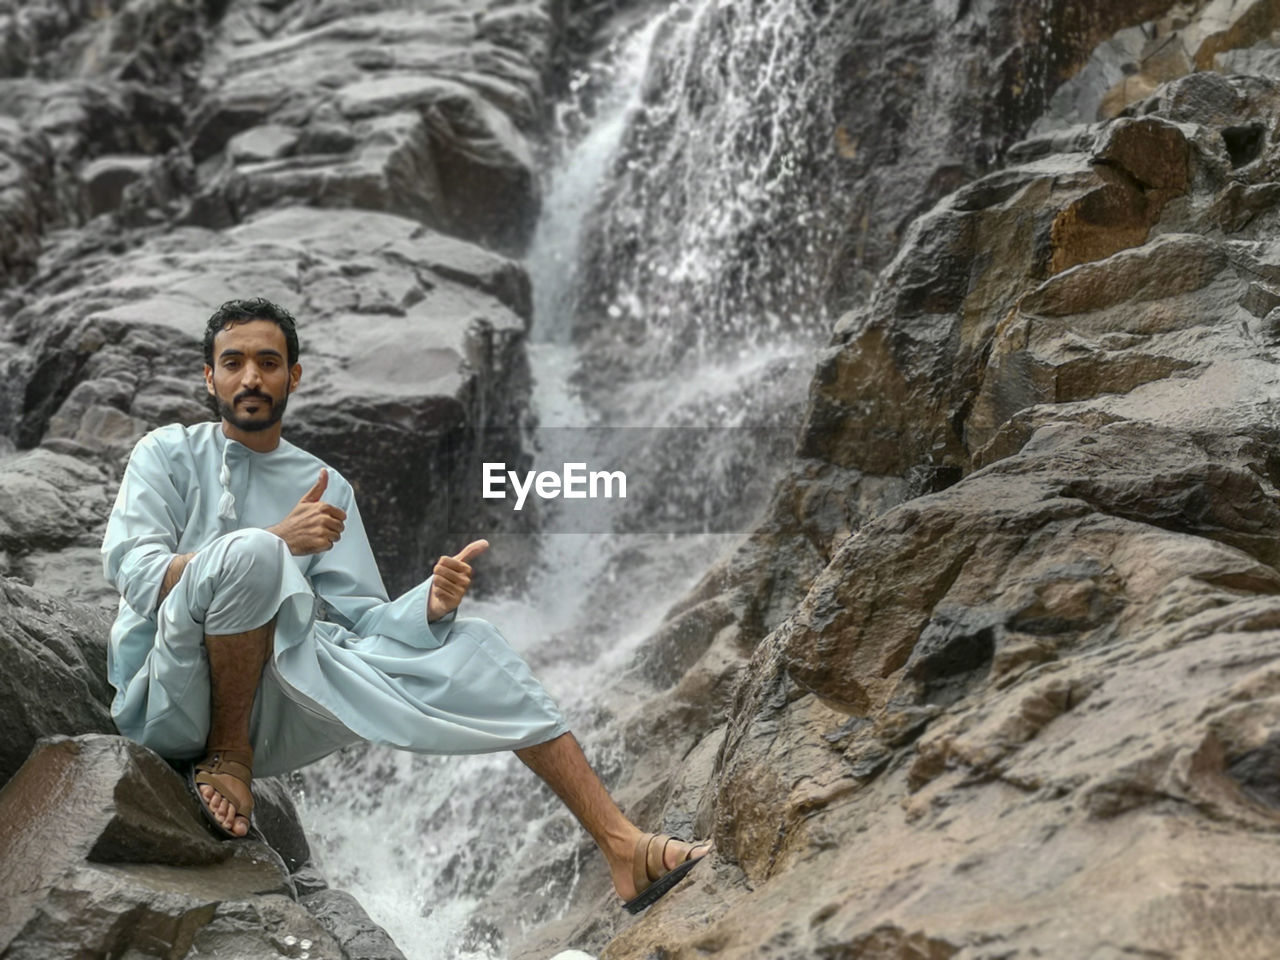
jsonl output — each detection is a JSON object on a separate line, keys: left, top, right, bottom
{"left": 200, "top": 620, "right": 275, "bottom": 837}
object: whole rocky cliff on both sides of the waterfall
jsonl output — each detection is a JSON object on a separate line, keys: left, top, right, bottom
{"left": 0, "top": 0, "right": 1280, "bottom": 960}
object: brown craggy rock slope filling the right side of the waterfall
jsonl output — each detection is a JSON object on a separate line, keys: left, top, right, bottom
{"left": 524, "top": 4, "right": 1280, "bottom": 957}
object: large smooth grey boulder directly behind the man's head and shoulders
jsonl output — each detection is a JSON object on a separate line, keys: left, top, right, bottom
{"left": 0, "top": 207, "right": 529, "bottom": 590}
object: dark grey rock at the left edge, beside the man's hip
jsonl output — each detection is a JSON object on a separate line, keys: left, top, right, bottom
{"left": 0, "top": 576, "right": 115, "bottom": 783}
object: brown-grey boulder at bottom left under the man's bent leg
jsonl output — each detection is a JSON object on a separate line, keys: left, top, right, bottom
{"left": 0, "top": 736, "right": 402, "bottom": 960}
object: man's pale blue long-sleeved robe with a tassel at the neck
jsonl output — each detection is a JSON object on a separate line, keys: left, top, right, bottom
{"left": 102, "top": 424, "right": 566, "bottom": 769}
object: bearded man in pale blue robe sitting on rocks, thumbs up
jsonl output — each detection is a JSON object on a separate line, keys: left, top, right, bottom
{"left": 102, "top": 298, "right": 709, "bottom": 913}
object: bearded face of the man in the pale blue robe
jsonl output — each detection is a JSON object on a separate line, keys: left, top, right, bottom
{"left": 205, "top": 320, "right": 302, "bottom": 433}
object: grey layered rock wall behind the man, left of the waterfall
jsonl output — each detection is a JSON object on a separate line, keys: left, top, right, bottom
{"left": 0, "top": 0, "right": 553, "bottom": 602}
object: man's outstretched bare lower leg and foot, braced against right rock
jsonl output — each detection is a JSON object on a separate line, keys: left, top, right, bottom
{"left": 516, "top": 733, "right": 711, "bottom": 900}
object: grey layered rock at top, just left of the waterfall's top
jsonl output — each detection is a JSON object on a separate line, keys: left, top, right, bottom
{"left": 186, "top": 4, "right": 553, "bottom": 251}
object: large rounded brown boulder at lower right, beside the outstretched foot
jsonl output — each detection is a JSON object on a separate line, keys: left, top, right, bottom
{"left": 629, "top": 409, "right": 1280, "bottom": 956}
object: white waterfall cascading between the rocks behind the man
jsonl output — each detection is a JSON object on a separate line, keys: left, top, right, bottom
{"left": 294, "top": 0, "right": 829, "bottom": 959}
